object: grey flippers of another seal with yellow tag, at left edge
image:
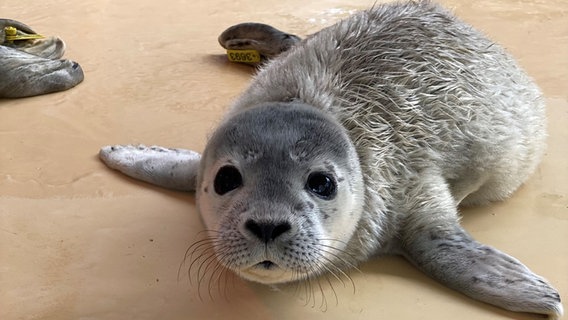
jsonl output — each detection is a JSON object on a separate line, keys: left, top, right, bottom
{"left": 0, "top": 19, "right": 84, "bottom": 98}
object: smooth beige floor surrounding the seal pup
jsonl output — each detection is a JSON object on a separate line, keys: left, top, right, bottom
{"left": 0, "top": 0, "right": 568, "bottom": 320}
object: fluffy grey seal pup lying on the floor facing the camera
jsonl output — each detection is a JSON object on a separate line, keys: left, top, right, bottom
{"left": 99, "top": 1, "right": 563, "bottom": 318}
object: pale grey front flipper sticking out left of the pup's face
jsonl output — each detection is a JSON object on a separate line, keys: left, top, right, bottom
{"left": 99, "top": 145, "right": 201, "bottom": 191}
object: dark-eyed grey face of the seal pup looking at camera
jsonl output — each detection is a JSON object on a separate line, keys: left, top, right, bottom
{"left": 197, "top": 104, "right": 364, "bottom": 283}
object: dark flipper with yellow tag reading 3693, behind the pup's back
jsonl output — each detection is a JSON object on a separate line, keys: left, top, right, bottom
{"left": 218, "top": 22, "right": 301, "bottom": 59}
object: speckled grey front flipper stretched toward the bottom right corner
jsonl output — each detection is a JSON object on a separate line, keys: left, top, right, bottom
{"left": 405, "top": 226, "right": 562, "bottom": 319}
